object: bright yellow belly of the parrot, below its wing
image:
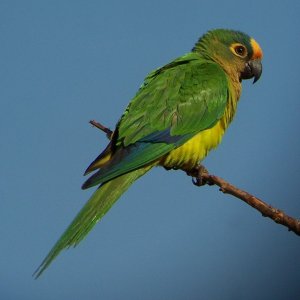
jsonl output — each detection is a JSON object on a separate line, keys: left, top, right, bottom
{"left": 159, "top": 120, "right": 225, "bottom": 170}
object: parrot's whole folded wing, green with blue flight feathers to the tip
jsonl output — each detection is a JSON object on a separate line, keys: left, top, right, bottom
{"left": 82, "top": 53, "right": 228, "bottom": 189}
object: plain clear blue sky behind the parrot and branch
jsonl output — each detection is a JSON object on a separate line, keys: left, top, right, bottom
{"left": 0, "top": 0, "right": 300, "bottom": 300}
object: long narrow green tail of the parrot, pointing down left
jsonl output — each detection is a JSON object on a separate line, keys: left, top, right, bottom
{"left": 33, "top": 166, "right": 152, "bottom": 278}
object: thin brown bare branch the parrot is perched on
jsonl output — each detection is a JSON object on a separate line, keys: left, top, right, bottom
{"left": 90, "top": 120, "right": 300, "bottom": 236}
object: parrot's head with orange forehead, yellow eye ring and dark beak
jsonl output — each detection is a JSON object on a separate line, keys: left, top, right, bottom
{"left": 192, "top": 29, "right": 263, "bottom": 83}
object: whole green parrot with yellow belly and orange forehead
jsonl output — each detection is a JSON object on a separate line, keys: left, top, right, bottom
{"left": 35, "top": 29, "right": 263, "bottom": 277}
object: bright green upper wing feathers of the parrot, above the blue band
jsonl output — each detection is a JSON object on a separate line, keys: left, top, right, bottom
{"left": 117, "top": 53, "right": 228, "bottom": 146}
